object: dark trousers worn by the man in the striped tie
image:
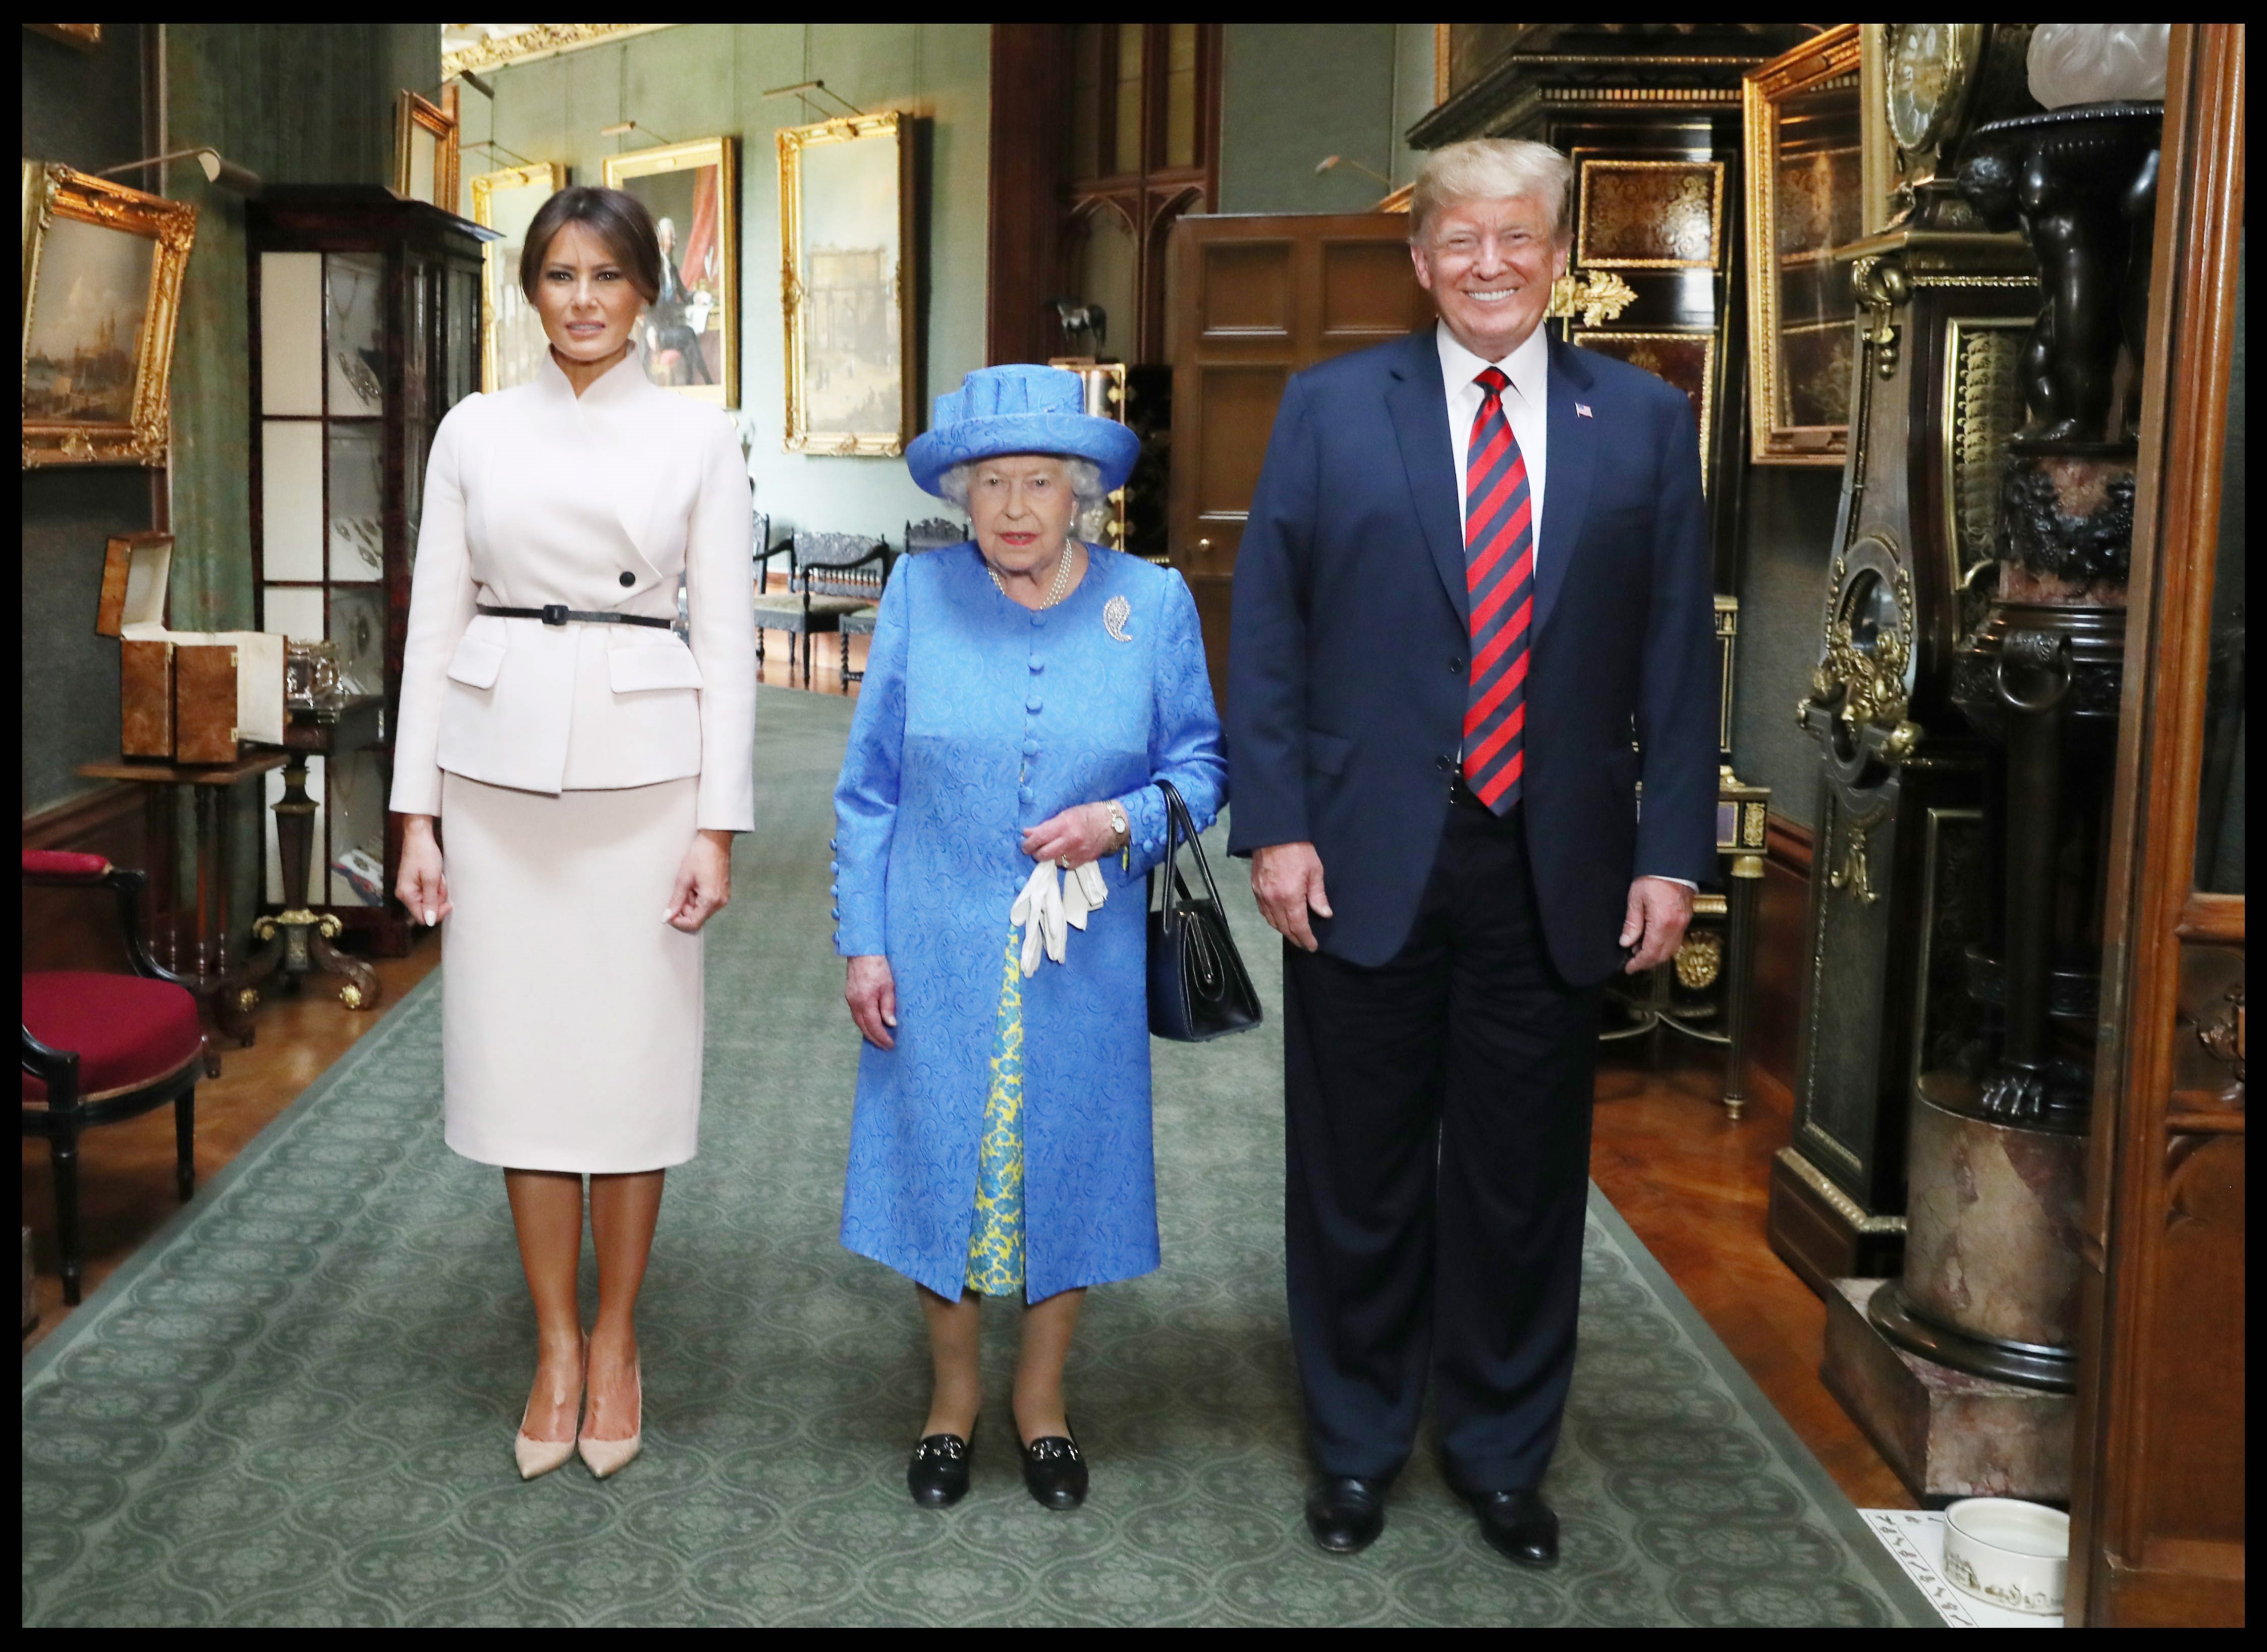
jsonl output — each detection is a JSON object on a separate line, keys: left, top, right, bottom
{"left": 1283, "top": 800, "right": 1603, "bottom": 1491}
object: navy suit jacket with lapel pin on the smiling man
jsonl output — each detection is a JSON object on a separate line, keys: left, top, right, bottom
{"left": 1227, "top": 328, "right": 1719, "bottom": 986}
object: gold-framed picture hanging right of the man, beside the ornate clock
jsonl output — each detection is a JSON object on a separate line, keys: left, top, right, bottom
{"left": 1741, "top": 23, "right": 1870, "bottom": 469}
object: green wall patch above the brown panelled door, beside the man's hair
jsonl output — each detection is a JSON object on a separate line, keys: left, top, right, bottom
{"left": 1220, "top": 23, "right": 1433, "bottom": 213}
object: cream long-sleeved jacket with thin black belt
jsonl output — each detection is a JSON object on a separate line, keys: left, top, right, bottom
{"left": 392, "top": 354, "right": 755, "bottom": 832}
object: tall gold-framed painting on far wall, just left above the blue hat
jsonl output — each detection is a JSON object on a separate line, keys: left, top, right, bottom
{"left": 780, "top": 114, "right": 918, "bottom": 456}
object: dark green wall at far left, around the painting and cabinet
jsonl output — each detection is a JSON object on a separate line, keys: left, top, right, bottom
{"left": 20, "top": 23, "right": 440, "bottom": 820}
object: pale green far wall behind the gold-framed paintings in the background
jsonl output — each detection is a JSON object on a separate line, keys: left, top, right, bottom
{"left": 463, "top": 23, "right": 990, "bottom": 539}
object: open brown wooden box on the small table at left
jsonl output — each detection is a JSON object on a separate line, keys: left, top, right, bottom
{"left": 95, "top": 532, "right": 284, "bottom": 763}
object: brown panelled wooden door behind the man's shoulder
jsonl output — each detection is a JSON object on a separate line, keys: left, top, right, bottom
{"left": 1170, "top": 213, "right": 1433, "bottom": 707}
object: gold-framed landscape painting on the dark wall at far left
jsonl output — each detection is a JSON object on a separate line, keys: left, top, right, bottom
{"left": 23, "top": 161, "right": 197, "bottom": 469}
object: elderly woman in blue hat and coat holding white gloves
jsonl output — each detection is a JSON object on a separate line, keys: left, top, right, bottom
{"left": 834, "top": 367, "right": 1227, "bottom": 1509}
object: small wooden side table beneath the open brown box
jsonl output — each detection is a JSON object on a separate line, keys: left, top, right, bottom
{"left": 79, "top": 746, "right": 288, "bottom": 1079}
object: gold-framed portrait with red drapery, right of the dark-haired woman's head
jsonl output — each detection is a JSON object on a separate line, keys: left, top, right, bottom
{"left": 605, "top": 138, "right": 739, "bottom": 408}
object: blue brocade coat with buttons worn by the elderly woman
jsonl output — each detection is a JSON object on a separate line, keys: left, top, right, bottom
{"left": 834, "top": 541, "right": 1227, "bottom": 1303}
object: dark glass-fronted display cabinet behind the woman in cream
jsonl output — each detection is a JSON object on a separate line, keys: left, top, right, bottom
{"left": 245, "top": 186, "right": 496, "bottom": 956}
